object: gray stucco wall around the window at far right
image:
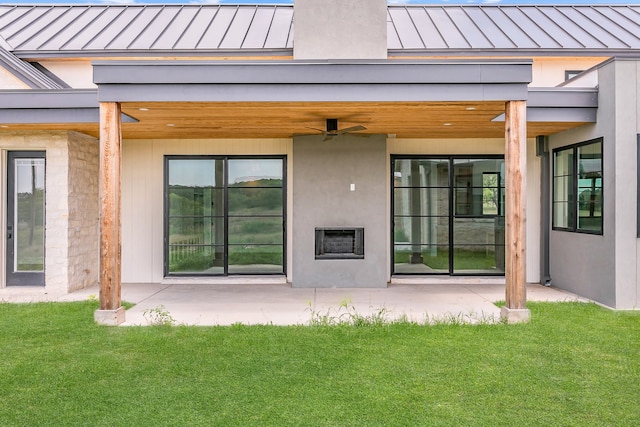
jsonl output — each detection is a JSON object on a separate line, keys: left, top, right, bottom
{"left": 549, "top": 60, "right": 640, "bottom": 309}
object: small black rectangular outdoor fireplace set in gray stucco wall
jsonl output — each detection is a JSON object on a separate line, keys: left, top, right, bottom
{"left": 316, "top": 227, "right": 364, "bottom": 259}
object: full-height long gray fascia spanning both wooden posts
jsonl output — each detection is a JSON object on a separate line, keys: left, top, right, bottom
{"left": 93, "top": 60, "right": 531, "bottom": 102}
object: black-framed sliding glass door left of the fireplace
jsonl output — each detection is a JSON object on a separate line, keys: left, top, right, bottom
{"left": 165, "top": 156, "right": 286, "bottom": 275}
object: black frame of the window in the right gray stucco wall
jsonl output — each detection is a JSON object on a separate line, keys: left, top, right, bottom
{"left": 551, "top": 137, "right": 604, "bottom": 236}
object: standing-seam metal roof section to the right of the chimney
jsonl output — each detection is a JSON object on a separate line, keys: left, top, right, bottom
{"left": 387, "top": 5, "right": 640, "bottom": 52}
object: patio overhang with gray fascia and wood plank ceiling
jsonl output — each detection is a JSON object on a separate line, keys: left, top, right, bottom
{"left": 0, "top": 57, "right": 597, "bottom": 139}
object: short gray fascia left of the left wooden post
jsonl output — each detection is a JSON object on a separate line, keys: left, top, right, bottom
{"left": 0, "top": 89, "right": 137, "bottom": 124}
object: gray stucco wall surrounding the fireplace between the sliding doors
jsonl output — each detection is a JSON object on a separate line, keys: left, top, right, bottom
{"left": 289, "top": 135, "right": 389, "bottom": 288}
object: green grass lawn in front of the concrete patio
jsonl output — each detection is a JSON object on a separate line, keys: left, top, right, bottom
{"left": 0, "top": 301, "right": 640, "bottom": 426}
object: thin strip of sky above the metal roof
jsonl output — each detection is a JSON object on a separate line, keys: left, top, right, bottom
{"left": 5, "top": 0, "right": 640, "bottom": 5}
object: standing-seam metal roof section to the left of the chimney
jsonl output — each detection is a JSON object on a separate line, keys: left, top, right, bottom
{"left": 0, "top": 5, "right": 293, "bottom": 52}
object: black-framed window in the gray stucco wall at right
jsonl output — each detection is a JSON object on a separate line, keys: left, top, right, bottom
{"left": 553, "top": 138, "right": 602, "bottom": 234}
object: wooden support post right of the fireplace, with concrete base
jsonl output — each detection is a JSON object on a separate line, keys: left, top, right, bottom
{"left": 502, "top": 101, "right": 530, "bottom": 322}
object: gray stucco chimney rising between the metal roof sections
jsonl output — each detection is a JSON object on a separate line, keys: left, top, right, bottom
{"left": 293, "top": 0, "right": 387, "bottom": 59}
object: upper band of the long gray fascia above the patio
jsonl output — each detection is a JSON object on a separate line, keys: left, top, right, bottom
{"left": 93, "top": 60, "right": 532, "bottom": 85}
